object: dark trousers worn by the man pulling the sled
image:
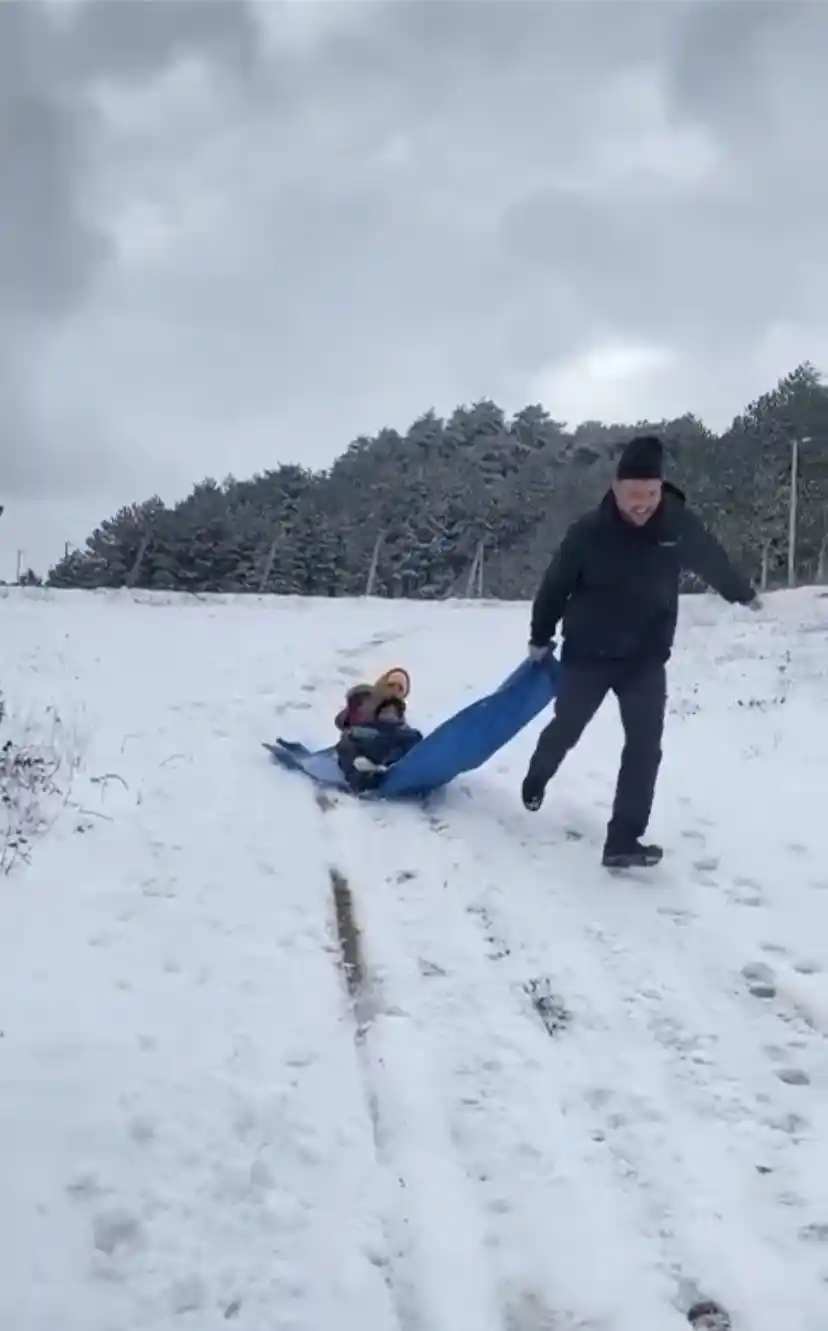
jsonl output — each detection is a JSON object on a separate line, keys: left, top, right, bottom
{"left": 528, "top": 662, "right": 667, "bottom": 847}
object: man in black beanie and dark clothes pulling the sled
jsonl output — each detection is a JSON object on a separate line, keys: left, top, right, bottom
{"left": 522, "top": 435, "right": 759, "bottom": 868}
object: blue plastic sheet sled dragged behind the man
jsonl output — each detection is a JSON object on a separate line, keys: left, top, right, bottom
{"left": 265, "top": 658, "right": 558, "bottom": 800}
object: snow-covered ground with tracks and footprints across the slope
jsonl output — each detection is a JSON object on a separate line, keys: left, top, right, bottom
{"left": 0, "top": 592, "right": 828, "bottom": 1331}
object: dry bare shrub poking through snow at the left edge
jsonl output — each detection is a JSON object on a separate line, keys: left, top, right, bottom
{"left": 0, "top": 696, "right": 76, "bottom": 877}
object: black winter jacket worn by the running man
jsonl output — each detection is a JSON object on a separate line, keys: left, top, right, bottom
{"left": 531, "top": 482, "right": 755, "bottom": 662}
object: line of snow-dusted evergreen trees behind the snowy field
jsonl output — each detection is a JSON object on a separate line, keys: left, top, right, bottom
{"left": 37, "top": 363, "right": 828, "bottom": 599}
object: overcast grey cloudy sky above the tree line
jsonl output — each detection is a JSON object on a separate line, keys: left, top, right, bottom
{"left": 0, "top": 0, "right": 828, "bottom": 576}
